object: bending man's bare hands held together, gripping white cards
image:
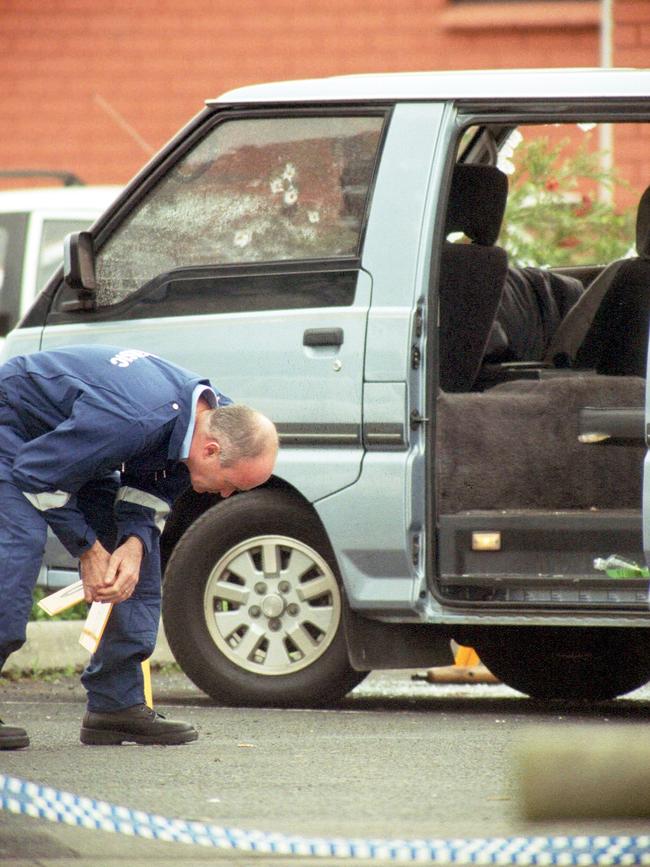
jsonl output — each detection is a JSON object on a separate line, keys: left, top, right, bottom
{"left": 79, "top": 536, "right": 143, "bottom": 604}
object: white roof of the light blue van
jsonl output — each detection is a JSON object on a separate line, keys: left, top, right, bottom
{"left": 213, "top": 67, "right": 650, "bottom": 105}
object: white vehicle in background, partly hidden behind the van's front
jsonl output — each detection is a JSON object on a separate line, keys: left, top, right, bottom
{"left": 0, "top": 184, "right": 121, "bottom": 344}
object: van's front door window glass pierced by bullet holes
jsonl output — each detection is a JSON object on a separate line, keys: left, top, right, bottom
{"left": 96, "top": 115, "right": 384, "bottom": 307}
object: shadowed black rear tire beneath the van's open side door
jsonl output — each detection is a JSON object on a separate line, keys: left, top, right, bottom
{"left": 475, "top": 627, "right": 650, "bottom": 701}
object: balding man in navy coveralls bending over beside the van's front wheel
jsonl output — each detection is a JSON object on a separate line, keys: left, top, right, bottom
{"left": 0, "top": 346, "right": 278, "bottom": 749}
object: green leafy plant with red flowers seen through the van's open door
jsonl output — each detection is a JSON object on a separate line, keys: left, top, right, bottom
{"left": 499, "top": 136, "right": 635, "bottom": 267}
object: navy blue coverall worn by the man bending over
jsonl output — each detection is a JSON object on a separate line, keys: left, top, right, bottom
{"left": 0, "top": 346, "right": 231, "bottom": 712}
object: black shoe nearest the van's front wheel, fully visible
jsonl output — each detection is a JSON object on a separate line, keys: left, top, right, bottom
{"left": 80, "top": 704, "right": 199, "bottom": 746}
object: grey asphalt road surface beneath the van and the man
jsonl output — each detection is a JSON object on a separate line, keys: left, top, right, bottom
{"left": 0, "top": 672, "right": 650, "bottom": 867}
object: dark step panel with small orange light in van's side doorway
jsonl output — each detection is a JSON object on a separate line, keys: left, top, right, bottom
{"left": 436, "top": 509, "right": 649, "bottom": 611}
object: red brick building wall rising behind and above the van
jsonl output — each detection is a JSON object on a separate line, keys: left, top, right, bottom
{"left": 0, "top": 0, "right": 650, "bottom": 182}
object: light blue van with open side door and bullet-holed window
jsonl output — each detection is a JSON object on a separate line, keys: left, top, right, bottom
{"left": 4, "top": 70, "right": 650, "bottom": 705}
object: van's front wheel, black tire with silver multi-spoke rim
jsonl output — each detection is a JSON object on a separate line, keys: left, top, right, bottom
{"left": 163, "top": 489, "right": 366, "bottom": 707}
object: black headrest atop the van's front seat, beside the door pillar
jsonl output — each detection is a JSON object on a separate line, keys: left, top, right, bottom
{"left": 445, "top": 163, "right": 508, "bottom": 246}
